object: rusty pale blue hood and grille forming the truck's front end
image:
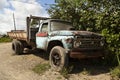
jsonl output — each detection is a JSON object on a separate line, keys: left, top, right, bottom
{"left": 49, "top": 30, "right": 103, "bottom": 49}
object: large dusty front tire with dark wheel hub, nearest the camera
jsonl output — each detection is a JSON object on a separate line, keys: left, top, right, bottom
{"left": 49, "top": 46, "right": 68, "bottom": 71}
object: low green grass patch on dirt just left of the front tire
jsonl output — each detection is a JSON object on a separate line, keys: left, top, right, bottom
{"left": 32, "top": 63, "right": 50, "bottom": 74}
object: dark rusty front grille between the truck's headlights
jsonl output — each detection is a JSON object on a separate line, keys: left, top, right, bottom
{"left": 74, "top": 36, "right": 101, "bottom": 49}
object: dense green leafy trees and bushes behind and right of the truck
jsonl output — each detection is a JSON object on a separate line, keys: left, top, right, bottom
{"left": 48, "top": 0, "right": 120, "bottom": 65}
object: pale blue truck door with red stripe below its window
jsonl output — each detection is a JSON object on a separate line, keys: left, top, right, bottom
{"left": 36, "top": 23, "right": 48, "bottom": 50}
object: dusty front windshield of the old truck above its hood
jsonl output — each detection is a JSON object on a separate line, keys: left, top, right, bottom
{"left": 51, "top": 21, "right": 73, "bottom": 31}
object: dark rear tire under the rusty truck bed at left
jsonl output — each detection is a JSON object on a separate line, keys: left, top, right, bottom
{"left": 12, "top": 41, "right": 23, "bottom": 55}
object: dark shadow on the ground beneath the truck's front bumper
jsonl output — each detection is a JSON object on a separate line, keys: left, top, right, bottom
{"left": 70, "top": 58, "right": 111, "bottom": 75}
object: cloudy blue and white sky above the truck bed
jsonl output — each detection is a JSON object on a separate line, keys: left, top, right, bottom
{"left": 0, "top": 0, "right": 54, "bottom": 34}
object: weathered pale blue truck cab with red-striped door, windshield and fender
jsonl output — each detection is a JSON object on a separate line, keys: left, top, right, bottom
{"left": 36, "top": 19, "right": 73, "bottom": 50}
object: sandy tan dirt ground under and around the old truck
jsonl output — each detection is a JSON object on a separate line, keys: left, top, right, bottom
{"left": 0, "top": 43, "right": 112, "bottom": 80}
